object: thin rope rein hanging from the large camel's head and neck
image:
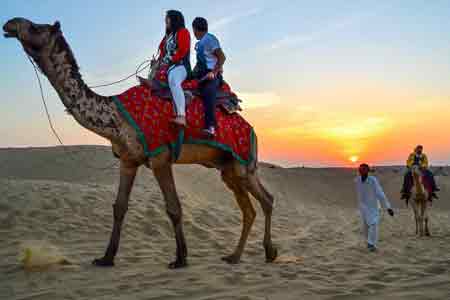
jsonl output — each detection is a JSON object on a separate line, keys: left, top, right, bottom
{"left": 27, "top": 54, "right": 151, "bottom": 171}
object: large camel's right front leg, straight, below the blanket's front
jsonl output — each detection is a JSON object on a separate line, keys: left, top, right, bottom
{"left": 153, "top": 164, "right": 187, "bottom": 269}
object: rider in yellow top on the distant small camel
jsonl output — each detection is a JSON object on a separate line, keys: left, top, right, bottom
{"left": 401, "top": 145, "right": 439, "bottom": 199}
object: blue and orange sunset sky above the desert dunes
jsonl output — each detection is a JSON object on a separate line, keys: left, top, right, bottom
{"left": 0, "top": 0, "right": 450, "bottom": 166}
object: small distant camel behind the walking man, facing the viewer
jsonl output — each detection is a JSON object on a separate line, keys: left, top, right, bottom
{"left": 411, "top": 166, "right": 431, "bottom": 236}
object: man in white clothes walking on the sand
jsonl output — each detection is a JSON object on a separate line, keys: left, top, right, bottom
{"left": 355, "top": 164, "right": 394, "bottom": 252}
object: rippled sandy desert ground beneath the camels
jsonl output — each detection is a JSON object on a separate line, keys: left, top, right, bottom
{"left": 0, "top": 147, "right": 450, "bottom": 300}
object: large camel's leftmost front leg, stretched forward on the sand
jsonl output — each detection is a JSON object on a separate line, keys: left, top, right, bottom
{"left": 92, "top": 161, "right": 137, "bottom": 266}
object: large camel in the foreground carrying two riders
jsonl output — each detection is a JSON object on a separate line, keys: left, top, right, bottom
{"left": 3, "top": 18, "right": 277, "bottom": 269}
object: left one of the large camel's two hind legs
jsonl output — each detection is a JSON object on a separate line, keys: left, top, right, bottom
{"left": 222, "top": 170, "right": 256, "bottom": 264}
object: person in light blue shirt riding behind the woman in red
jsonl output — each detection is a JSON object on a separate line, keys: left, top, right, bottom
{"left": 192, "top": 17, "right": 225, "bottom": 137}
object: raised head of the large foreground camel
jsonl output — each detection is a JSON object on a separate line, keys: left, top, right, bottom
{"left": 3, "top": 18, "right": 62, "bottom": 63}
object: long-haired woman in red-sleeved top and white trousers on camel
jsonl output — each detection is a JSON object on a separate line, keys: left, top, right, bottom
{"left": 158, "top": 10, "right": 191, "bottom": 126}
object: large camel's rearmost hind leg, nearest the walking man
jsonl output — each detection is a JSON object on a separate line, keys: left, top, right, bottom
{"left": 248, "top": 173, "right": 278, "bottom": 262}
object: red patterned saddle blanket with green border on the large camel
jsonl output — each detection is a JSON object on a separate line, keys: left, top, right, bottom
{"left": 113, "top": 85, "right": 255, "bottom": 165}
